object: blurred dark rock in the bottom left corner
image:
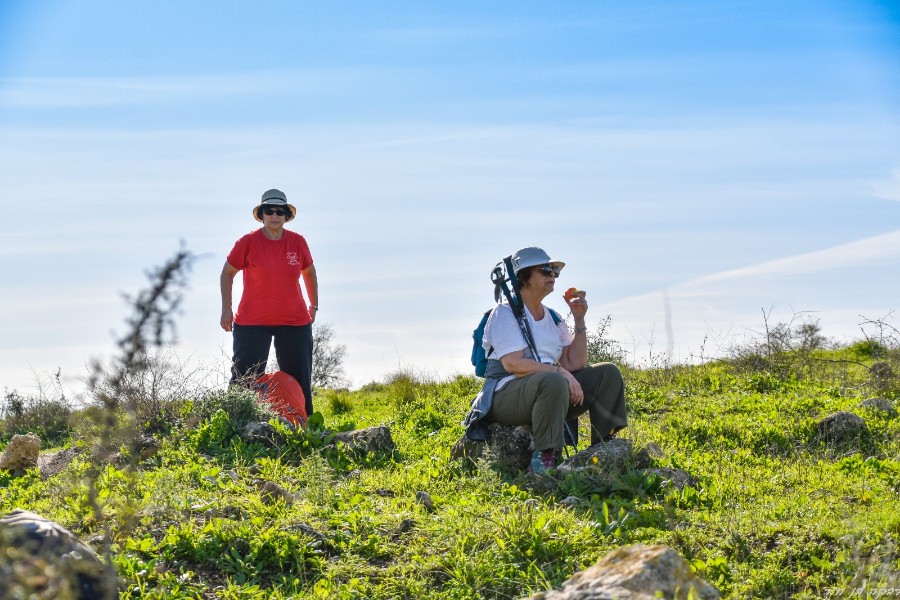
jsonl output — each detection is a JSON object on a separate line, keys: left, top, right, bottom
{"left": 0, "top": 509, "right": 108, "bottom": 600}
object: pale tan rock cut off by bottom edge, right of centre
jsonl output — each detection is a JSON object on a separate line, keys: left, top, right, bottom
{"left": 529, "top": 544, "right": 720, "bottom": 600}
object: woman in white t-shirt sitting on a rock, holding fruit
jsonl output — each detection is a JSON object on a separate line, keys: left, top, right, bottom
{"left": 483, "top": 247, "right": 627, "bottom": 474}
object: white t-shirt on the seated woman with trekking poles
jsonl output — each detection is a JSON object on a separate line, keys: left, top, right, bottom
{"left": 481, "top": 304, "right": 574, "bottom": 390}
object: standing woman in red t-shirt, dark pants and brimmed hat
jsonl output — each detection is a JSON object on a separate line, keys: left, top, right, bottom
{"left": 219, "top": 189, "right": 319, "bottom": 415}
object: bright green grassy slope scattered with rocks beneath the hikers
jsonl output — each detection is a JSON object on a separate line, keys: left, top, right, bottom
{"left": 0, "top": 348, "right": 900, "bottom": 598}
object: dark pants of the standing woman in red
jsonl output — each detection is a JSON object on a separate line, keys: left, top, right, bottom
{"left": 231, "top": 323, "right": 313, "bottom": 415}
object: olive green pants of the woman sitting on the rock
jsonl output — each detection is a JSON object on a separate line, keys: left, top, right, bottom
{"left": 487, "top": 363, "right": 628, "bottom": 450}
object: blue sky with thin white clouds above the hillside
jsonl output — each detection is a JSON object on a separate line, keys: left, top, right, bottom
{"left": 0, "top": 0, "right": 900, "bottom": 392}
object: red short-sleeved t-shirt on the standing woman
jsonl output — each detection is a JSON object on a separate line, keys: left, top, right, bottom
{"left": 228, "top": 229, "right": 312, "bottom": 325}
